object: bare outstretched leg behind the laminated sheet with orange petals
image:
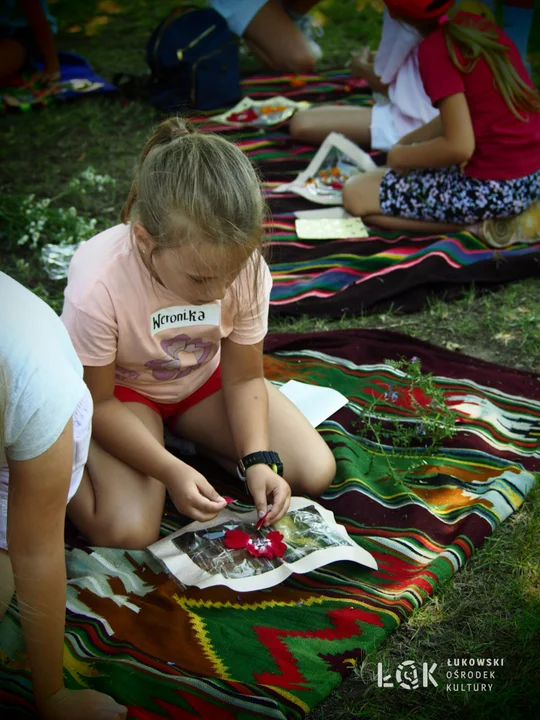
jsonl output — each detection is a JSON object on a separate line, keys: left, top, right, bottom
{"left": 290, "top": 105, "right": 372, "bottom": 147}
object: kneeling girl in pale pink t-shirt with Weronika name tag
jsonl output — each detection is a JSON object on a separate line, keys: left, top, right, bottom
{"left": 62, "top": 118, "right": 335, "bottom": 548}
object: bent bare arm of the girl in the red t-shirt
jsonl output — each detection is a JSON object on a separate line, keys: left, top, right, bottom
{"left": 388, "top": 93, "right": 475, "bottom": 170}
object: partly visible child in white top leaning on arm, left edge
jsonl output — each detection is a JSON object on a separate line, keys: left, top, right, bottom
{"left": 0, "top": 273, "right": 126, "bottom": 720}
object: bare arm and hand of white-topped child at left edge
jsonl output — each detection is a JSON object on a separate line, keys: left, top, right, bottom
{"left": 7, "top": 420, "right": 126, "bottom": 720}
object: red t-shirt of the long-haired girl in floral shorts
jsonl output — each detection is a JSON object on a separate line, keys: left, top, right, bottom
{"left": 418, "top": 13, "right": 540, "bottom": 180}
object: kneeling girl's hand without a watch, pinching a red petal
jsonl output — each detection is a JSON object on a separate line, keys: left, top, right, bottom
{"left": 165, "top": 462, "right": 227, "bottom": 522}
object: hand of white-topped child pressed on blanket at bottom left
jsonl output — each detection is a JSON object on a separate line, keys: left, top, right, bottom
{"left": 38, "top": 688, "right": 127, "bottom": 720}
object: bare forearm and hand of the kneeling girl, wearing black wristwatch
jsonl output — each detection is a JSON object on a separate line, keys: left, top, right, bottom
{"left": 221, "top": 339, "right": 291, "bottom": 525}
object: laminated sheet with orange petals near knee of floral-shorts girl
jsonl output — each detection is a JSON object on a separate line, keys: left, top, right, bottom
{"left": 274, "top": 133, "right": 377, "bottom": 205}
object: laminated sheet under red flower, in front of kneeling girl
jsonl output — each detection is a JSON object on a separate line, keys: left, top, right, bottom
{"left": 148, "top": 497, "right": 377, "bottom": 592}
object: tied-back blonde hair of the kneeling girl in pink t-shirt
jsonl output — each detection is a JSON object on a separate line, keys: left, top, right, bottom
{"left": 121, "top": 117, "right": 265, "bottom": 268}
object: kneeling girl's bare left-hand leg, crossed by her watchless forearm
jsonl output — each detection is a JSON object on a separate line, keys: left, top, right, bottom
{"left": 67, "top": 403, "right": 165, "bottom": 549}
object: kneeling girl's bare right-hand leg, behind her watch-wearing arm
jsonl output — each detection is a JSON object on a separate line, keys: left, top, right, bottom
{"left": 173, "top": 382, "right": 336, "bottom": 497}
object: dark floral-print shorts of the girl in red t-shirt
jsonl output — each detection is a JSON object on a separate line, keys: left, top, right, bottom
{"left": 379, "top": 165, "right": 540, "bottom": 225}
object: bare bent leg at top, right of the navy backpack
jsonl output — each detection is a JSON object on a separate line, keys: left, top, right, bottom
{"left": 243, "top": 0, "right": 316, "bottom": 73}
